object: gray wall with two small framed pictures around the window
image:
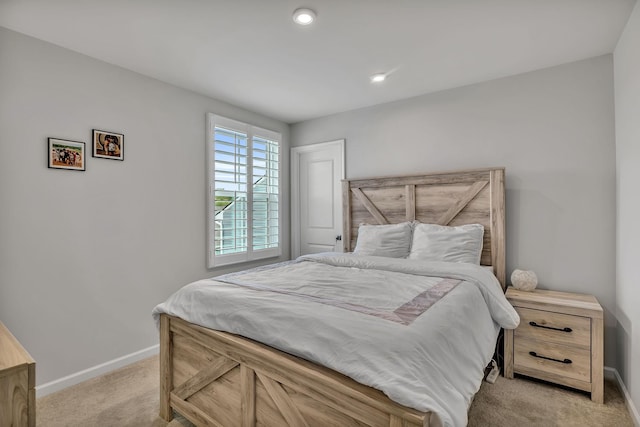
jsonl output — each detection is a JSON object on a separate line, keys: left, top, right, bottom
{"left": 0, "top": 27, "right": 290, "bottom": 384}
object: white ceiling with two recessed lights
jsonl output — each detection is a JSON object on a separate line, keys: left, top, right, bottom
{"left": 0, "top": 0, "right": 635, "bottom": 123}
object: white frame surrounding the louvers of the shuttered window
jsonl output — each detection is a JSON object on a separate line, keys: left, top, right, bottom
{"left": 206, "top": 113, "right": 283, "bottom": 268}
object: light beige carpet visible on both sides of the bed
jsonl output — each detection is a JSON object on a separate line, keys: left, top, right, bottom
{"left": 36, "top": 357, "right": 633, "bottom": 427}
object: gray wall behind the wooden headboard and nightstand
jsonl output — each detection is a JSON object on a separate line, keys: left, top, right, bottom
{"left": 291, "top": 55, "right": 616, "bottom": 366}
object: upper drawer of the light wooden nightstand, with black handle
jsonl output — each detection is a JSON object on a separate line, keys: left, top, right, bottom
{"left": 515, "top": 307, "right": 591, "bottom": 352}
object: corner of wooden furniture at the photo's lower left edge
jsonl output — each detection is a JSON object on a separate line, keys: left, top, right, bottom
{"left": 0, "top": 322, "right": 36, "bottom": 427}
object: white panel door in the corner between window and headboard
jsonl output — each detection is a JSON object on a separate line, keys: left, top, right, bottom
{"left": 291, "top": 139, "right": 344, "bottom": 258}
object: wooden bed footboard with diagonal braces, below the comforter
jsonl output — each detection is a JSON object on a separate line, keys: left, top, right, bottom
{"left": 160, "top": 314, "right": 429, "bottom": 427}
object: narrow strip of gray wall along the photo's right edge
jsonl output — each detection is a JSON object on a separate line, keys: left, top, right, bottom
{"left": 614, "top": 0, "right": 640, "bottom": 414}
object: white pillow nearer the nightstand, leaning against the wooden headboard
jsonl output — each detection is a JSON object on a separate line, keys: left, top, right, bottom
{"left": 409, "top": 223, "right": 484, "bottom": 265}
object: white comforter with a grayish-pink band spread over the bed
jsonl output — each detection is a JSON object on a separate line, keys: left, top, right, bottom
{"left": 153, "top": 253, "right": 519, "bottom": 426}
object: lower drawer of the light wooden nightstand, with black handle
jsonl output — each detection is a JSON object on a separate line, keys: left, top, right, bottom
{"left": 513, "top": 339, "right": 591, "bottom": 382}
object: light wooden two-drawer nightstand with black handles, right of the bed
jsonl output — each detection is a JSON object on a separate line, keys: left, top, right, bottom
{"left": 504, "top": 287, "right": 604, "bottom": 403}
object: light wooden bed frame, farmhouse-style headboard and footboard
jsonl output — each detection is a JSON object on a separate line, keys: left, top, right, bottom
{"left": 160, "top": 168, "right": 505, "bottom": 427}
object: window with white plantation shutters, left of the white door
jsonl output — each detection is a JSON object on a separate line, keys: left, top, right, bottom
{"left": 207, "top": 114, "right": 281, "bottom": 267}
